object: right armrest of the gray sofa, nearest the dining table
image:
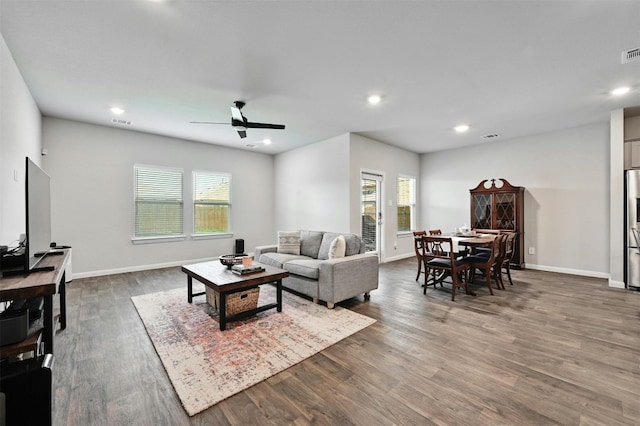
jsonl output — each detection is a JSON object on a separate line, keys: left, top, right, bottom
{"left": 318, "top": 253, "right": 378, "bottom": 304}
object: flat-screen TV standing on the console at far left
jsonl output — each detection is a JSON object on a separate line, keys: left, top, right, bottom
{"left": 25, "top": 157, "right": 51, "bottom": 271}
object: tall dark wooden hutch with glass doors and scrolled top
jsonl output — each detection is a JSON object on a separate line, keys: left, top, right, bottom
{"left": 469, "top": 178, "right": 524, "bottom": 268}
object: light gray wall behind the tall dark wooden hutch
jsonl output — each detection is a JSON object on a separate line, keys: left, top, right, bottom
{"left": 421, "top": 123, "right": 610, "bottom": 277}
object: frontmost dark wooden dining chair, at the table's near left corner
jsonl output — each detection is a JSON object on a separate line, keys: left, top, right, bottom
{"left": 422, "top": 235, "right": 469, "bottom": 301}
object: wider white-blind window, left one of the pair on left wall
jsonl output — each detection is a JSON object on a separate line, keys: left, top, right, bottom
{"left": 133, "top": 164, "right": 183, "bottom": 238}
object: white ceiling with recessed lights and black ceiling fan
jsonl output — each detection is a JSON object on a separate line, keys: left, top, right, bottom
{"left": 0, "top": 0, "right": 640, "bottom": 153}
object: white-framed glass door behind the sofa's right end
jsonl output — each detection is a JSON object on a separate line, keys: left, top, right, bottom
{"left": 360, "top": 172, "right": 382, "bottom": 253}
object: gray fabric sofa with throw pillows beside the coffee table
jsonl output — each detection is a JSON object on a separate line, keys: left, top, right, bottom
{"left": 254, "top": 230, "right": 378, "bottom": 309}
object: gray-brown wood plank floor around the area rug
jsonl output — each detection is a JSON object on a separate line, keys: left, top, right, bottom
{"left": 54, "top": 259, "right": 640, "bottom": 426}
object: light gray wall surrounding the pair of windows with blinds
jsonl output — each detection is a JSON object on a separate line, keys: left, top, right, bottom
{"left": 43, "top": 118, "right": 275, "bottom": 277}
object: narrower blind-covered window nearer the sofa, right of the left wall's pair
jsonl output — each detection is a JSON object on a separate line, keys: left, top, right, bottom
{"left": 193, "top": 171, "right": 231, "bottom": 235}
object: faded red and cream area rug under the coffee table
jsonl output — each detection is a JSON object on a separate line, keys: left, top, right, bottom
{"left": 131, "top": 285, "right": 375, "bottom": 416}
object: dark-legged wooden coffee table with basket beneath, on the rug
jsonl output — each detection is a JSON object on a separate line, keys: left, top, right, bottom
{"left": 182, "top": 260, "right": 289, "bottom": 331}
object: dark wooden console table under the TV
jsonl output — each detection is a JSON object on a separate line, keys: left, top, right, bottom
{"left": 0, "top": 250, "right": 69, "bottom": 358}
